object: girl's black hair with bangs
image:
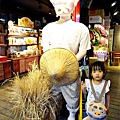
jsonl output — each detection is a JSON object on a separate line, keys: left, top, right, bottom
{"left": 89, "top": 61, "right": 106, "bottom": 79}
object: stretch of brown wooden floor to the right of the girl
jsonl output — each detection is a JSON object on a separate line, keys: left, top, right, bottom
{"left": 105, "top": 66, "right": 120, "bottom": 120}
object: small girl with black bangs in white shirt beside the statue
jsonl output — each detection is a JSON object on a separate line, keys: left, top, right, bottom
{"left": 82, "top": 61, "right": 110, "bottom": 120}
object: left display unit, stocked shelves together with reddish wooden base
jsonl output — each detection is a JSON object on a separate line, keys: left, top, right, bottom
{"left": 0, "top": 18, "right": 40, "bottom": 80}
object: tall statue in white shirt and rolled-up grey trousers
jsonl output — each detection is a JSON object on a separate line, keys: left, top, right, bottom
{"left": 42, "top": 0, "right": 91, "bottom": 120}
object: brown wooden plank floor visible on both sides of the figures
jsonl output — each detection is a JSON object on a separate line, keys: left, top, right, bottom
{"left": 0, "top": 67, "right": 120, "bottom": 120}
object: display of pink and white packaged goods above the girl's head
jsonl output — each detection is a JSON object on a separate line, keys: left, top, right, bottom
{"left": 90, "top": 24, "right": 108, "bottom": 62}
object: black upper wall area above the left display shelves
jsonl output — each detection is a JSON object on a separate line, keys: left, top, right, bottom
{"left": 0, "top": 0, "right": 56, "bottom": 28}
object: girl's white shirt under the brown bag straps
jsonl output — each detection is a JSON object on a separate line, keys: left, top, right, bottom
{"left": 85, "top": 79, "right": 110, "bottom": 110}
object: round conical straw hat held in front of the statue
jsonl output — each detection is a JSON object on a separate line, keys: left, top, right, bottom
{"left": 40, "top": 48, "right": 79, "bottom": 86}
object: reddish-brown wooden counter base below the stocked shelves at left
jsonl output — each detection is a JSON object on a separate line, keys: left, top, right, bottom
{"left": 0, "top": 55, "right": 40, "bottom": 80}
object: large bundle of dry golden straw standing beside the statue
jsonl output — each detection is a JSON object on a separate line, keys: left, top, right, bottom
{"left": 10, "top": 62, "right": 55, "bottom": 120}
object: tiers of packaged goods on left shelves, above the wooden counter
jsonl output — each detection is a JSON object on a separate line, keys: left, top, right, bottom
{"left": 7, "top": 25, "right": 39, "bottom": 57}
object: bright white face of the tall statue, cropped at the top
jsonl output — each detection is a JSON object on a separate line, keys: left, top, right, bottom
{"left": 50, "top": 0, "right": 79, "bottom": 17}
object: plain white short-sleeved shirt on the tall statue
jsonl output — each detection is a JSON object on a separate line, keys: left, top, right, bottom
{"left": 42, "top": 20, "right": 91, "bottom": 54}
